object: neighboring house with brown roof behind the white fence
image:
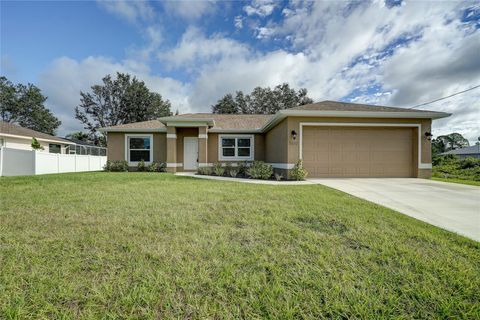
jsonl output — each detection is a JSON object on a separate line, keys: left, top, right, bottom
{"left": 0, "top": 121, "right": 72, "bottom": 153}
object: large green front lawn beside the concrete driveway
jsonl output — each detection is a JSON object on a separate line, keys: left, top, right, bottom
{"left": 0, "top": 173, "right": 480, "bottom": 319}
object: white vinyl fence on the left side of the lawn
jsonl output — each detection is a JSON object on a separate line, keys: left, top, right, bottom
{"left": 0, "top": 147, "right": 107, "bottom": 176}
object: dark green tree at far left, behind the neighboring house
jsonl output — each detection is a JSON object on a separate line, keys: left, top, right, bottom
{"left": 0, "top": 77, "right": 61, "bottom": 135}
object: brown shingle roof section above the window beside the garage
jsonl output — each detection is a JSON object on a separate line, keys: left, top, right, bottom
{"left": 177, "top": 113, "right": 273, "bottom": 130}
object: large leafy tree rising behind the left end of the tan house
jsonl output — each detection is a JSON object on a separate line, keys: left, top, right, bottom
{"left": 75, "top": 72, "right": 172, "bottom": 142}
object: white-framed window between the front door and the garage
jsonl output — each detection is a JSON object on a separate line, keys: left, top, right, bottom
{"left": 219, "top": 135, "right": 253, "bottom": 160}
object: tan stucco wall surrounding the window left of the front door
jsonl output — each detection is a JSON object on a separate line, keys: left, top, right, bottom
{"left": 107, "top": 132, "right": 167, "bottom": 162}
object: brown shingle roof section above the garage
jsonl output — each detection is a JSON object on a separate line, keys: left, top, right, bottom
{"left": 289, "top": 100, "right": 440, "bottom": 113}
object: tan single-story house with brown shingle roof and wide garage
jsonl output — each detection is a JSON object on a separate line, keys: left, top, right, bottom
{"left": 100, "top": 101, "right": 450, "bottom": 177}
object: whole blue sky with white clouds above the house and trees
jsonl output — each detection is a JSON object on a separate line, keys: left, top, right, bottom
{"left": 0, "top": 0, "right": 480, "bottom": 142}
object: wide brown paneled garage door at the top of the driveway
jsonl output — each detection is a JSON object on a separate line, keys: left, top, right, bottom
{"left": 302, "top": 126, "right": 413, "bottom": 177}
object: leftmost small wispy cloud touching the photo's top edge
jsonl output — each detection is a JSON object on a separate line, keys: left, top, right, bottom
{"left": 97, "top": 0, "right": 155, "bottom": 23}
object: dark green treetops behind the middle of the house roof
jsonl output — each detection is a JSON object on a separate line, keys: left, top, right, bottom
{"left": 212, "top": 83, "right": 313, "bottom": 114}
